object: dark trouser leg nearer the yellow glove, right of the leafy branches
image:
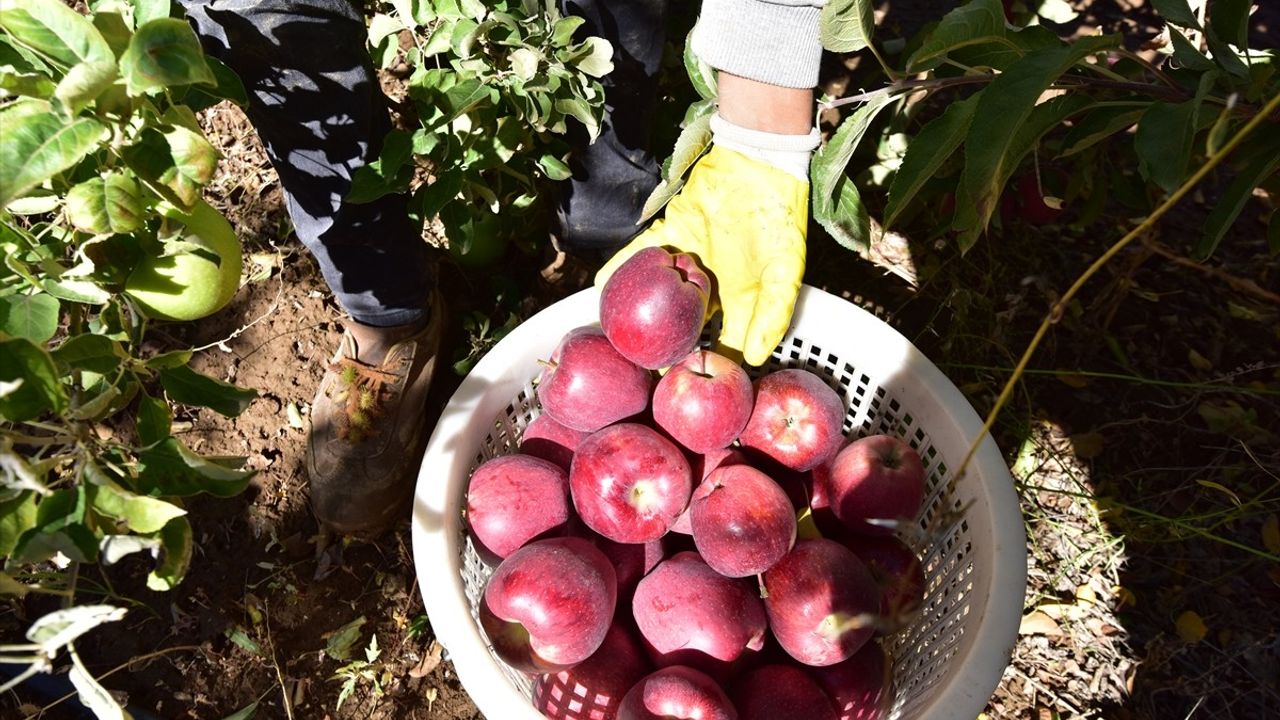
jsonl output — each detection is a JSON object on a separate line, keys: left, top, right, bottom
{"left": 554, "top": 0, "right": 668, "bottom": 252}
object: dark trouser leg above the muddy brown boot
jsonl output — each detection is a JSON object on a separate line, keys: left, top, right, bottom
{"left": 179, "top": 0, "right": 435, "bottom": 327}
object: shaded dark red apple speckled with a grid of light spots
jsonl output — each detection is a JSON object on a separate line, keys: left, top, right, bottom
{"left": 534, "top": 623, "right": 653, "bottom": 720}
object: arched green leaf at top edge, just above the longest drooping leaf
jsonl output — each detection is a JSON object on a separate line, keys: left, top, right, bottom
{"left": 906, "top": 0, "right": 1061, "bottom": 73}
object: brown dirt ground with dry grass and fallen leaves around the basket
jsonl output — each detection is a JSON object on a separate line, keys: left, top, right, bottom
{"left": 0, "top": 0, "right": 1280, "bottom": 720}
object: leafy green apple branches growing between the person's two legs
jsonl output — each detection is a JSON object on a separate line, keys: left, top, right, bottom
{"left": 352, "top": 0, "right": 613, "bottom": 264}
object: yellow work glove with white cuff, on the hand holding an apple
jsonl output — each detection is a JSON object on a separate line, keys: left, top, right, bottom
{"left": 595, "top": 117, "right": 818, "bottom": 365}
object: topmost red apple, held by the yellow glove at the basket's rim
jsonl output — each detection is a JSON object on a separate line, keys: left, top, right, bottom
{"left": 600, "top": 247, "right": 710, "bottom": 369}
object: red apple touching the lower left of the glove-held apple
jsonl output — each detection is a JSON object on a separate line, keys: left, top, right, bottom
{"left": 538, "top": 327, "right": 653, "bottom": 433}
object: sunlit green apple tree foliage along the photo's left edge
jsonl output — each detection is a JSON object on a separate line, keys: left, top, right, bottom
{"left": 0, "top": 0, "right": 255, "bottom": 716}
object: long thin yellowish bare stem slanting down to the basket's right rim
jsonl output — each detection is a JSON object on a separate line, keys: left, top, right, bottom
{"left": 955, "top": 88, "right": 1280, "bottom": 481}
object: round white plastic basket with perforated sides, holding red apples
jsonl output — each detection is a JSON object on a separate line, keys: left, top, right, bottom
{"left": 413, "top": 286, "right": 1027, "bottom": 720}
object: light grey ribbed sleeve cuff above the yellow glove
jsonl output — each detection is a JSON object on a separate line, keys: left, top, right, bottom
{"left": 692, "top": 0, "right": 823, "bottom": 88}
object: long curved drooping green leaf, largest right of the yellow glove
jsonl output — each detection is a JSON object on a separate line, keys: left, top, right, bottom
{"left": 952, "top": 36, "right": 1119, "bottom": 247}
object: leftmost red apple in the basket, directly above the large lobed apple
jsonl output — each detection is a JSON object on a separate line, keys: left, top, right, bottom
{"left": 467, "top": 455, "right": 572, "bottom": 564}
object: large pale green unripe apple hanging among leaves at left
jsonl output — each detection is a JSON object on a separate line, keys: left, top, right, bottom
{"left": 124, "top": 200, "right": 241, "bottom": 320}
